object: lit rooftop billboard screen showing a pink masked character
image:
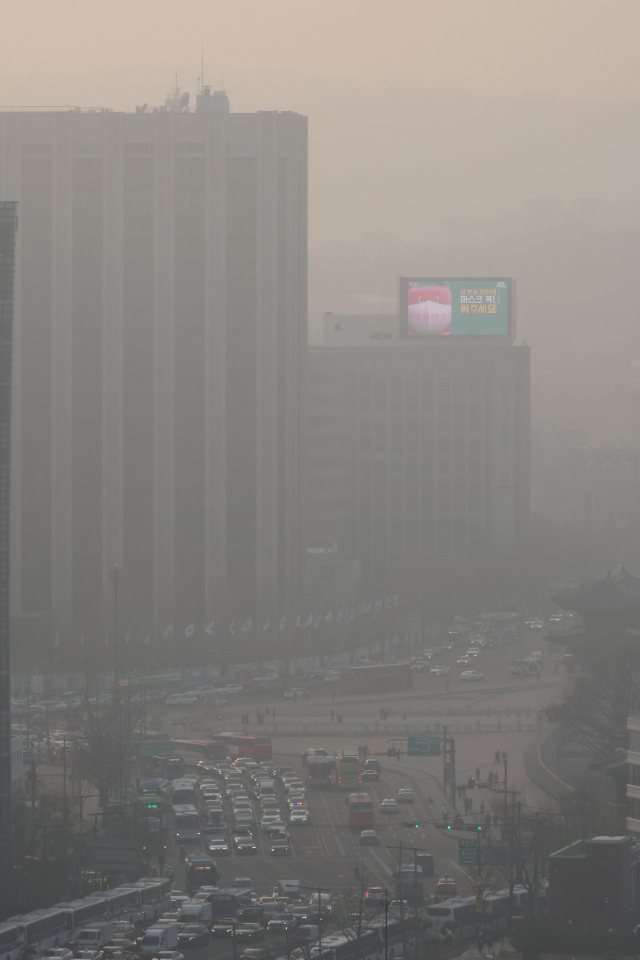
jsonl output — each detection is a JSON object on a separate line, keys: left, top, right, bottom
{"left": 400, "top": 277, "right": 511, "bottom": 337}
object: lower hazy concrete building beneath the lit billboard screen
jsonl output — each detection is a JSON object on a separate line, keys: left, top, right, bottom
{"left": 306, "top": 336, "right": 529, "bottom": 588}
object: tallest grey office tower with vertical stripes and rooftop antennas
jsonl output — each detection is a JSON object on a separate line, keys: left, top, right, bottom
{"left": 0, "top": 94, "right": 307, "bottom": 644}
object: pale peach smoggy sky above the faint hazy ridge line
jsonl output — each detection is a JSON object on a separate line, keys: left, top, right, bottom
{"left": 0, "top": 0, "right": 640, "bottom": 99}
